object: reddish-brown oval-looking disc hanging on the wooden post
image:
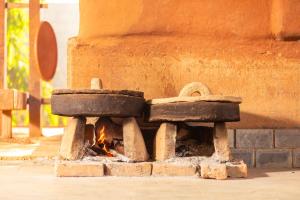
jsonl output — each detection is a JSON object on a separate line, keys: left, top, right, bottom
{"left": 35, "top": 21, "right": 57, "bottom": 81}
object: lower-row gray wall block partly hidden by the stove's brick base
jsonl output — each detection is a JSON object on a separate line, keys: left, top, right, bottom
{"left": 231, "top": 149, "right": 255, "bottom": 168}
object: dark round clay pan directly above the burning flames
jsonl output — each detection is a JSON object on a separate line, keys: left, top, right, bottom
{"left": 51, "top": 89, "right": 145, "bottom": 117}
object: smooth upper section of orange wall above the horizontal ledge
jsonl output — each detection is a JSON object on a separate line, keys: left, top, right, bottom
{"left": 79, "top": 0, "right": 272, "bottom": 38}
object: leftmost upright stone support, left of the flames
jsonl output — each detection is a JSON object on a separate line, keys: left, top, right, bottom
{"left": 59, "top": 117, "right": 86, "bottom": 160}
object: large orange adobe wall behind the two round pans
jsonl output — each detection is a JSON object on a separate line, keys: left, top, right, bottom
{"left": 68, "top": 0, "right": 300, "bottom": 128}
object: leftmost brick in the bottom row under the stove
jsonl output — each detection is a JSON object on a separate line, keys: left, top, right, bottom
{"left": 55, "top": 161, "right": 104, "bottom": 177}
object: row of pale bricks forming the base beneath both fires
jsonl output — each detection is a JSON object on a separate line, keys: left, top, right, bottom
{"left": 55, "top": 157, "right": 247, "bottom": 179}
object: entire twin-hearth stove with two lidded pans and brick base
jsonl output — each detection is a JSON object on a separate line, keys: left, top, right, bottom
{"left": 51, "top": 78, "right": 247, "bottom": 179}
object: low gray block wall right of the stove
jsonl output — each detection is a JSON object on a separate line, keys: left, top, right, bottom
{"left": 228, "top": 129, "right": 300, "bottom": 168}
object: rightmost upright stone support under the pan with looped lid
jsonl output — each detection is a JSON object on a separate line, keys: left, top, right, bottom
{"left": 213, "top": 122, "right": 230, "bottom": 161}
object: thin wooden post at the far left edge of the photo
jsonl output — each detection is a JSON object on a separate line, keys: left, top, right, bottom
{"left": 0, "top": 0, "right": 6, "bottom": 136}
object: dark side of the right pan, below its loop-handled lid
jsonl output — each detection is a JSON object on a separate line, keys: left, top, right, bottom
{"left": 146, "top": 101, "right": 240, "bottom": 122}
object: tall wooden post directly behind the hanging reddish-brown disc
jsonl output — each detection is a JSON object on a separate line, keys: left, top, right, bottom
{"left": 29, "top": 0, "right": 42, "bottom": 137}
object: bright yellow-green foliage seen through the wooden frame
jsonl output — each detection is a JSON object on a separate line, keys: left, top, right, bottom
{"left": 6, "top": 0, "right": 66, "bottom": 126}
